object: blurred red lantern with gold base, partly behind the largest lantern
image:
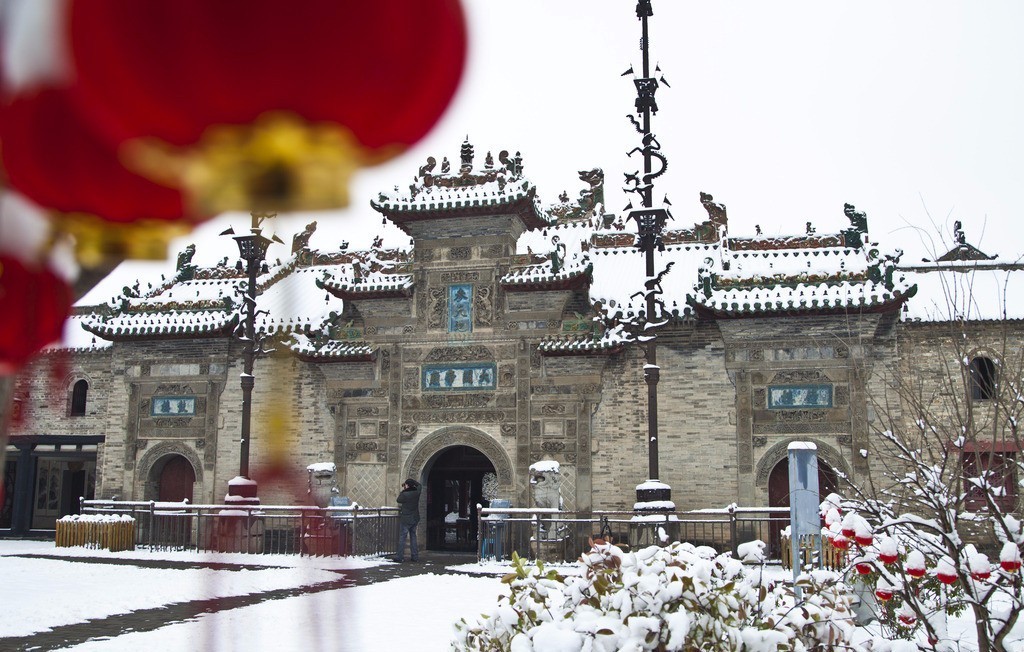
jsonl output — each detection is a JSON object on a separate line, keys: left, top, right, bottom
{"left": 0, "top": 88, "right": 198, "bottom": 265}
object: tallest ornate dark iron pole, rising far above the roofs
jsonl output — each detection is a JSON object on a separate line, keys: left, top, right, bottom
{"left": 624, "top": 0, "right": 674, "bottom": 512}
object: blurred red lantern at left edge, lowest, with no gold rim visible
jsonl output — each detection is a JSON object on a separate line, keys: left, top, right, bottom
{"left": 0, "top": 254, "right": 72, "bottom": 376}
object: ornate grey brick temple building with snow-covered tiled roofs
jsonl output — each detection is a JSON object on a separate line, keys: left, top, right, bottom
{"left": 0, "top": 141, "right": 1024, "bottom": 547}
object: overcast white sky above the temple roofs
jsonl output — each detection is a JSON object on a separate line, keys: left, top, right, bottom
{"left": 81, "top": 0, "right": 1024, "bottom": 302}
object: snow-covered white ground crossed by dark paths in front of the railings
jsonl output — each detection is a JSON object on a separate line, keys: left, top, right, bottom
{"left": 0, "top": 539, "right": 1024, "bottom": 652}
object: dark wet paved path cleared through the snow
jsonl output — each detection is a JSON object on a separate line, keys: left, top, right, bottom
{"left": 0, "top": 553, "right": 476, "bottom": 652}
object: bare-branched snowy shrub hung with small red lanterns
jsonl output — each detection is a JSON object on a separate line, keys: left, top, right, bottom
{"left": 821, "top": 481, "right": 1024, "bottom": 652}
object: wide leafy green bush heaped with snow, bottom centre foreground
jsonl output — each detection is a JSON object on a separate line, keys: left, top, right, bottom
{"left": 455, "top": 542, "right": 854, "bottom": 652}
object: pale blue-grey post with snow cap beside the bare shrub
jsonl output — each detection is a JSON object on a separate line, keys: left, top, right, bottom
{"left": 788, "top": 441, "right": 821, "bottom": 602}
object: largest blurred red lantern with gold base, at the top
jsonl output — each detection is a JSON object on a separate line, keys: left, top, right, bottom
{"left": 70, "top": 0, "right": 466, "bottom": 213}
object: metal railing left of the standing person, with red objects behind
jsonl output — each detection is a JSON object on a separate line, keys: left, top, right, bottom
{"left": 81, "top": 501, "right": 398, "bottom": 556}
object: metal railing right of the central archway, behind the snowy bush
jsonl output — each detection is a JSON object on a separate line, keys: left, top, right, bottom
{"left": 478, "top": 507, "right": 790, "bottom": 561}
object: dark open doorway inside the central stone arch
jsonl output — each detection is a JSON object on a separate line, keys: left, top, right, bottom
{"left": 427, "top": 446, "right": 495, "bottom": 552}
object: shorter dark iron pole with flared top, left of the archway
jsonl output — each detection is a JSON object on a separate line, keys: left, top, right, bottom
{"left": 221, "top": 213, "right": 281, "bottom": 505}
